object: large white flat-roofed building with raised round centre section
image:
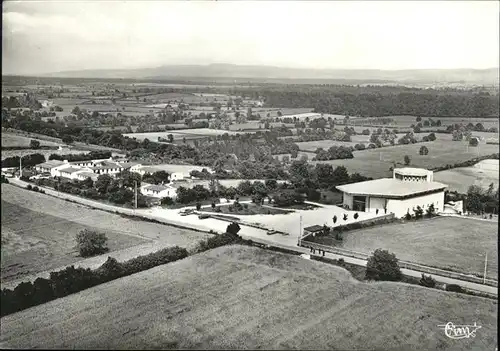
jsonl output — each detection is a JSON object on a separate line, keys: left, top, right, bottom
{"left": 337, "top": 168, "right": 447, "bottom": 217}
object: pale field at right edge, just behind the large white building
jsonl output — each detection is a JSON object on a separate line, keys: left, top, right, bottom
{"left": 434, "top": 160, "right": 499, "bottom": 193}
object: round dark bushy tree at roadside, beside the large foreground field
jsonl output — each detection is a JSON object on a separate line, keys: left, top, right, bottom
{"left": 366, "top": 249, "right": 402, "bottom": 281}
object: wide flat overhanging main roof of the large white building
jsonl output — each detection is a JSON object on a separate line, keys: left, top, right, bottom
{"left": 336, "top": 178, "right": 447, "bottom": 198}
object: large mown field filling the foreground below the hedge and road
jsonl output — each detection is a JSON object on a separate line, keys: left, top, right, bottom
{"left": 0, "top": 246, "right": 498, "bottom": 350}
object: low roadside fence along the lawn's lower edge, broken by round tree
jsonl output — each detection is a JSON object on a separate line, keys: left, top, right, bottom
{"left": 300, "top": 241, "right": 498, "bottom": 287}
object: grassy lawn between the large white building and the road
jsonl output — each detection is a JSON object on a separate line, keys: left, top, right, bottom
{"left": 312, "top": 217, "right": 498, "bottom": 279}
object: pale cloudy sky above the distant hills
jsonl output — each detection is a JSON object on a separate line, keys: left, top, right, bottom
{"left": 2, "top": 0, "right": 500, "bottom": 74}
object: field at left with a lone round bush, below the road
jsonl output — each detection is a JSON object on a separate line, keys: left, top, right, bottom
{"left": 1, "top": 184, "right": 211, "bottom": 281}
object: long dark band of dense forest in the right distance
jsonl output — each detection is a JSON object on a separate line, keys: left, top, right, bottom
{"left": 243, "top": 87, "right": 499, "bottom": 117}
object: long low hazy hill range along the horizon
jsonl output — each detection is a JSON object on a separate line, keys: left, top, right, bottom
{"left": 39, "top": 64, "right": 499, "bottom": 85}
